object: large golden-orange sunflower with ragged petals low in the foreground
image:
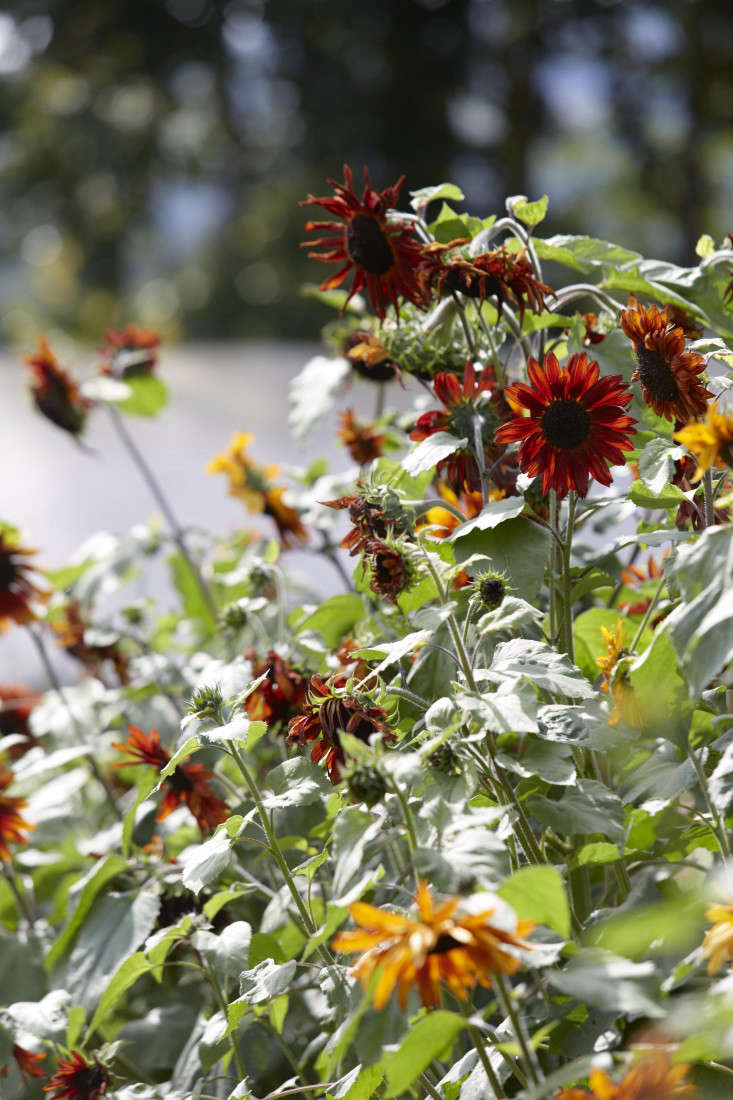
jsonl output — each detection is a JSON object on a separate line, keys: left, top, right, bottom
{"left": 331, "top": 881, "right": 534, "bottom": 1011}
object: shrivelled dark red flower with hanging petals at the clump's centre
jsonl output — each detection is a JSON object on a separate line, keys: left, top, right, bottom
{"left": 287, "top": 673, "right": 395, "bottom": 783}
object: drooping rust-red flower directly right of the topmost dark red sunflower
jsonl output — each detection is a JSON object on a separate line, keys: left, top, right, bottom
{"left": 418, "top": 240, "right": 555, "bottom": 317}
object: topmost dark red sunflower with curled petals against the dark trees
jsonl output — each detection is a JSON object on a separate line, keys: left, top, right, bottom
{"left": 300, "top": 165, "right": 425, "bottom": 318}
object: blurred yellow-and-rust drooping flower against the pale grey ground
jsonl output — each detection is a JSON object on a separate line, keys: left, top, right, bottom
{"left": 206, "top": 431, "right": 307, "bottom": 548}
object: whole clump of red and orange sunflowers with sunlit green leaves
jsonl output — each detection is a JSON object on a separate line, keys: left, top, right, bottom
{"left": 0, "top": 167, "right": 733, "bottom": 1100}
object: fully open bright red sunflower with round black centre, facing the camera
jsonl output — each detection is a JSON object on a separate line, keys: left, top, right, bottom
{"left": 496, "top": 352, "right": 636, "bottom": 498}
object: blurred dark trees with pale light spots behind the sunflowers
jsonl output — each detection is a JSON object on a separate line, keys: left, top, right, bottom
{"left": 0, "top": 0, "right": 733, "bottom": 342}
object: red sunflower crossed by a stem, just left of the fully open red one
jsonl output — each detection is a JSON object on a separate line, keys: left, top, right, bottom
{"left": 409, "top": 362, "right": 512, "bottom": 494}
